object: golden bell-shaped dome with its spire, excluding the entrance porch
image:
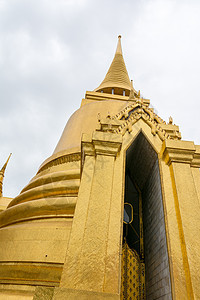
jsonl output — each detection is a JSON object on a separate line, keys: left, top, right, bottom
{"left": 0, "top": 38, "right": 133, "bottom": 285}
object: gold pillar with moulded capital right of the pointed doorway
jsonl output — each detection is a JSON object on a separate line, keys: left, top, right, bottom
{"left": 162, "top": 140, "right": 200, "bottom": 299}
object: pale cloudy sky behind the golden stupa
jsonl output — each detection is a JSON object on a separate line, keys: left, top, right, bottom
{"left": 0, "top": 0, "right": 200, "bottom": 197}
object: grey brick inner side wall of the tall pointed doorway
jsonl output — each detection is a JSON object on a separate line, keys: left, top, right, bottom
{"left": 143, "top": 161, "right": 172, "bottom": 299}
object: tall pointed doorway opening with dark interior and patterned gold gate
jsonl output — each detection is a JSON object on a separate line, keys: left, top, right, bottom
{"left": 121, "top": 132, "right": 172, "bottom": 300}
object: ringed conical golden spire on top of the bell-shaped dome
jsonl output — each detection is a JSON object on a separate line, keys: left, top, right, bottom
{"left": 95, "top": 35, "right": 131, "bottom": 96}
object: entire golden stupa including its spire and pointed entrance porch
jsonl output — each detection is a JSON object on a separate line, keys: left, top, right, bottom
{"left": 0, "top": 36, "right": 200, "bottom": 300}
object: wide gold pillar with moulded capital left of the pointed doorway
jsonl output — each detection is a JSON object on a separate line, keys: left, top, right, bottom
{"left": 54, "top": 131, "right": 123, "bottom": 300}
